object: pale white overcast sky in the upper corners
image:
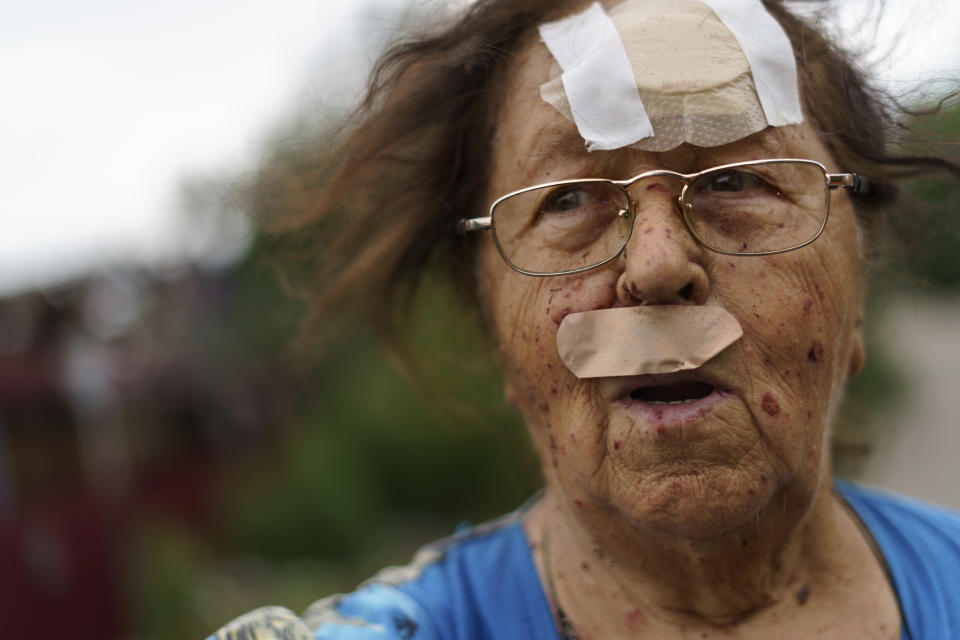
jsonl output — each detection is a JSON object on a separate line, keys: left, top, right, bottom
{"left": 0, "top": 0, "right": 960, "bottom": 293}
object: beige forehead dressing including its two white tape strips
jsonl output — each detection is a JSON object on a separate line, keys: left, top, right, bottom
{"left": 540, "top": 0, "right": 803, "bottom": 151}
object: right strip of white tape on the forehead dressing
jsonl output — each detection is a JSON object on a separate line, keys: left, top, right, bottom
{"left": 688, "top": 0, "right": 803, "bottom": 127}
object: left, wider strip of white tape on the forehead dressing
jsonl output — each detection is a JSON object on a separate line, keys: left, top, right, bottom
{"left": 540, "top": 2, "right": 653, "bottom": 151}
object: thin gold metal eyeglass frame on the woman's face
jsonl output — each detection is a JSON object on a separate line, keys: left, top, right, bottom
{"left": 457, "top": 158, "right": 868, "bottom": 278}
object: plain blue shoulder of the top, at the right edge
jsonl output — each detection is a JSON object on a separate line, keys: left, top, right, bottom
{"left": 835, "top": 481, "right": 960, "bottom": 638}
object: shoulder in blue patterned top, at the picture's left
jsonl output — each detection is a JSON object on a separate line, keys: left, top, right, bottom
{"left": 214, "top": 514, "right": 552, "bottom": 640}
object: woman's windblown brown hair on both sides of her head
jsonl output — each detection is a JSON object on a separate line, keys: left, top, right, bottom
{"left": 253, "top": 0, "right": 960, "bottom": 350}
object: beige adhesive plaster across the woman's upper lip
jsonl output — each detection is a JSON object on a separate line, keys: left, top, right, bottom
{"left": 557, "top": 305, "right": 743, "bottom": 378}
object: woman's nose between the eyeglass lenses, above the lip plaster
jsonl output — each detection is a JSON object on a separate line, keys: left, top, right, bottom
{"left": 617, "top": 182, "right": 710, "bottom": 306}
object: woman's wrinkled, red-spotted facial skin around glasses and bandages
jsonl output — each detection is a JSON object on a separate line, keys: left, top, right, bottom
{"left": 479, "top": 43, "right": 862, "bottom": 537}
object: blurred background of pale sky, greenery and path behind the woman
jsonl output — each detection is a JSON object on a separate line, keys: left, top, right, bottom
{"left": 0, "top": 0, "right": 960, "bottom": 640}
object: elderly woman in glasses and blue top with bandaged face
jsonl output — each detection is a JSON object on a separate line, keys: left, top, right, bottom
{"left": 212, "top": 0, "right": 960, "bottom": 640}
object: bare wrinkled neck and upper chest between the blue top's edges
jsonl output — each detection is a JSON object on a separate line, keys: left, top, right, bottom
{"left": 525, "top": 462, "right": 899, "bottom": 640}
